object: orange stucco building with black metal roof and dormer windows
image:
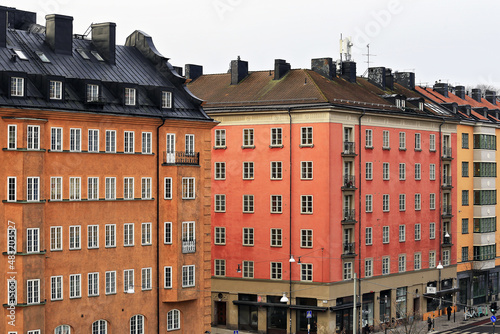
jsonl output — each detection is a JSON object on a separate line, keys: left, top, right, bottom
{"left": 0, "top": 7, "right": 215, "bottom": 334}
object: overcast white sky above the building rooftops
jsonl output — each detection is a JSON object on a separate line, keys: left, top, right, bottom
{"left": 6, "top": 0, "right": 500, "bottom": 88}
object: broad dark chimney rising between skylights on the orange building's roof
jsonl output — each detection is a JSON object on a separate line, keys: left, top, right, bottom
{"left": 45, "top": 14, "right": 73, "bottom": 55}
